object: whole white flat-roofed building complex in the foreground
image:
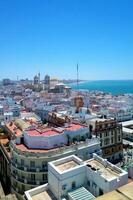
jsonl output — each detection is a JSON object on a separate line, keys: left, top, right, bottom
{"left": 25, "top": 154, "right": 128, "bottom": 200}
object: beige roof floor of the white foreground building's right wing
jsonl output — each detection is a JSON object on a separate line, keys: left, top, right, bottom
{"left": 86, "top": 160, "right": 120, "bottom": 180}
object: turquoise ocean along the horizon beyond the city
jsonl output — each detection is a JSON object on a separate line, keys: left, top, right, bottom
{"left": 71, "top": 80, "right": 133, "bottom": 95}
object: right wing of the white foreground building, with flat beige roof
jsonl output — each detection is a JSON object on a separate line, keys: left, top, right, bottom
{"left": 86, "top": 155, "right": 128, "bottom": 197}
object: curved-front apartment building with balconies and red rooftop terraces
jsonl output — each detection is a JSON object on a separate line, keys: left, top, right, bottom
{"left": 10, "top": 123, "right": 101, "bottom": 199}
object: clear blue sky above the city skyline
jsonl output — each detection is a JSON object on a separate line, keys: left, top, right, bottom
{"left": 0, "top": 0, "right": 133, "bottom": 80}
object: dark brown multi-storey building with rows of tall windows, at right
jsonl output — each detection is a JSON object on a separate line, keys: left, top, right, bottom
{"left": 88, "top": 118, "right": 123, "bottom": 163}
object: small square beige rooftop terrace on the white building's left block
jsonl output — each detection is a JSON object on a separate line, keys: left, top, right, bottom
{"left": 55, "top": 160, "right": 79, "bottom": 172}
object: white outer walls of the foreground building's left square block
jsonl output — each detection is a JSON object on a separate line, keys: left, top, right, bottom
{"left": 48, "top": 162, "right": 86, "bottom": 200}
